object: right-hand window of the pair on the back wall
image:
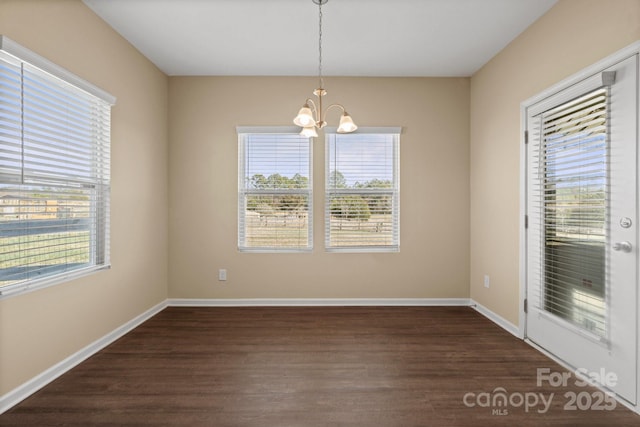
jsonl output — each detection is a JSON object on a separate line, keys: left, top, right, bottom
{"left": 325, "top": 128, "right": 400, "bottom": 252}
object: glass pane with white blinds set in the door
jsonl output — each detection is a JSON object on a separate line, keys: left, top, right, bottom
{"left": 531, "top": 88, "right": 608, "bottom": 336}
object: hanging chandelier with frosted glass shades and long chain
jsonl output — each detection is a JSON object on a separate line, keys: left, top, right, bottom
{"left": 293, "top": 0, "right": 358, "bottom": 138}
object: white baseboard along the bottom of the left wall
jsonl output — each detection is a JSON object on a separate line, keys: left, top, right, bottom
{"left": 0, "top": 300, "right": 167, "bottom": 414}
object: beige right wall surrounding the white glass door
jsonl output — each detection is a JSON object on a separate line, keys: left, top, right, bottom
{"left": 470, "top": 0, "right": 640, "bottom": 325}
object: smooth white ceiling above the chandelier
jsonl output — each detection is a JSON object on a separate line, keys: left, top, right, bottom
{"left": 83, "top": 0, "right": 557, "bottom": 77}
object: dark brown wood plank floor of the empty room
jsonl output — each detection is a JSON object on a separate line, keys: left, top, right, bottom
{"left": 0, "top": 307, "right": 640, "bottom": 427}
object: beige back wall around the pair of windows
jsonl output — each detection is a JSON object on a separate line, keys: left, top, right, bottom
{"left": 169, "top": 77, "right": 469, "bottom": 298}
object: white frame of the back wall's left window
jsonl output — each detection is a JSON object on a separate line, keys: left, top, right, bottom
{"left": 236, "top": 126, "right": 314, "bottom": 253}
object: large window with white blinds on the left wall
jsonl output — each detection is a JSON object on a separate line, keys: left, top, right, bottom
{"left": 0, "top": 36, "right": 115, "bottom": 295}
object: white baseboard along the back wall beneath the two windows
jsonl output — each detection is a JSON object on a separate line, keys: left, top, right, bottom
{"left": 167, "top": 298, "right": 471, "bottom": 307}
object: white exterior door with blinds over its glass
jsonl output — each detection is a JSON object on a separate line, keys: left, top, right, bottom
{"left": 526, "top": 55, "right": 638, "bottom": 403}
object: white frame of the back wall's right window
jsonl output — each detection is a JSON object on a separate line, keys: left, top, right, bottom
{"left": 324, "top": 127, "right": 402, "bottom": 253}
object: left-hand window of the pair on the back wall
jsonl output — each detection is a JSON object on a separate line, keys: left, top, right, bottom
{"left": 238, "top": 127, "right": 313, "bottom": 252}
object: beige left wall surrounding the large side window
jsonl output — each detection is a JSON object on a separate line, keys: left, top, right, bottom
{"left": 0, "top": 0, "right": 168, "bottom": 396}
